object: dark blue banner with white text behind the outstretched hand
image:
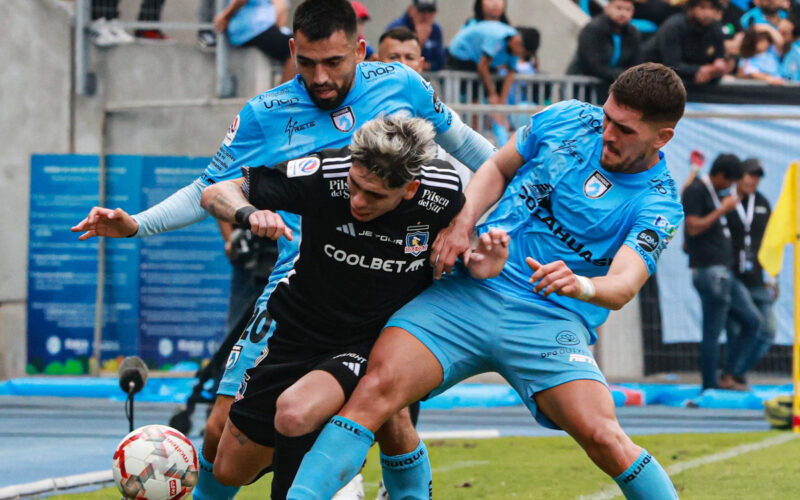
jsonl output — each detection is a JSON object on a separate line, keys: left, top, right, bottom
{"left": 28, "top": 155, "right": 230, "bottom": 374}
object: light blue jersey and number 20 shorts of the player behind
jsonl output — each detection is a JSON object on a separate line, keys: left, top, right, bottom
{"left": 209, "top": 62, "right": 460, "bottom": 395}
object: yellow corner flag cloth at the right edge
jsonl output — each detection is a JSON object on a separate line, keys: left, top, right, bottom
{"left": 758, "top": 162, "right": 798, "bottom": 276}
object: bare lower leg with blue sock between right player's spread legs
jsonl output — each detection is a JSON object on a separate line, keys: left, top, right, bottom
{"left": 375, "top": 408, "right": 433, "bottom": 500}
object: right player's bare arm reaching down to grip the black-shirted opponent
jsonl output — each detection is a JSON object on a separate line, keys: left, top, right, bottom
{"left": 431, "top": 135, "right": 524, "bottom": 279}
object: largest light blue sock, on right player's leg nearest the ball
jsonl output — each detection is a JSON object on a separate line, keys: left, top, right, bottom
{"left": 286, "top": 415, "right": 375, "bottom": 500}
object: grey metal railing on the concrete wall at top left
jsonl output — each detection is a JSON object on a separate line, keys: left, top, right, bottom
{"left": 74, "top": 0, "right": 236, "bottom": 97}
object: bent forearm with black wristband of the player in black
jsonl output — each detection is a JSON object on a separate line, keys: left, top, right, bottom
{"left": 200, "top": 178, "right": 292, "bottom": 240}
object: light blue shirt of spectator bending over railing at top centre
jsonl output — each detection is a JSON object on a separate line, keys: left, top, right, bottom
{"left": 447, "top": 21, "right": 517, "bottom": 68}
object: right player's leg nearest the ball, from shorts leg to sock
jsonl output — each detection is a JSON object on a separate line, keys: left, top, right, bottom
{"left": 288, "top": 274, "right": 494, "bottom": 500}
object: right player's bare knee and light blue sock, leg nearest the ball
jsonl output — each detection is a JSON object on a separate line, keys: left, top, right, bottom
{"left": 287, "top": 328, "right": 442, "bottom": 500}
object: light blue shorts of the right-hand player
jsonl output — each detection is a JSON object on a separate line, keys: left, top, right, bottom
{"left": 386, "top": 271, "right": 608, "bottom": 429}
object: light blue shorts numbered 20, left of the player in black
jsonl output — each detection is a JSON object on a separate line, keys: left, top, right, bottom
{"left": 217, "top": 300, "right": 275, "bottom": 396}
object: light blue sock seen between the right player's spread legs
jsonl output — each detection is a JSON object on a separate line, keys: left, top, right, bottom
{"left": 381, "top": 439, "right": 433, "bottom": 500}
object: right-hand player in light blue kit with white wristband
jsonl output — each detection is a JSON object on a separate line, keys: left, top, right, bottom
{"left": 288, "top": 63, "right": 686, "bottom": 500}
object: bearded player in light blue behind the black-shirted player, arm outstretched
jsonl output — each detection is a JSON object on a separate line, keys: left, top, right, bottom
{"left": 73, "top": 0, "right": 494, "bottom": 499}
